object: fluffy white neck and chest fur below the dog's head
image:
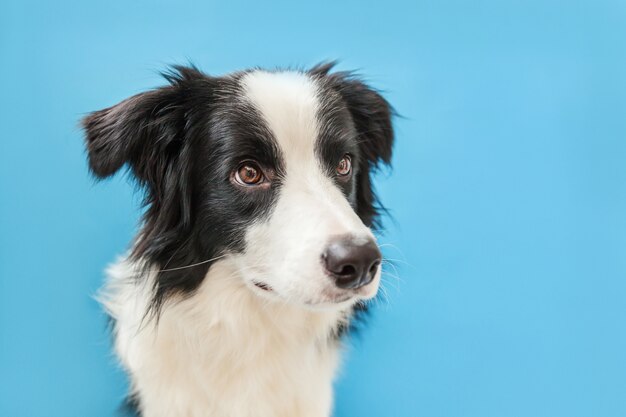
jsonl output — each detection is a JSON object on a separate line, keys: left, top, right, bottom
{"left": 104, "top": 261, "right": 348, "bottom": 417}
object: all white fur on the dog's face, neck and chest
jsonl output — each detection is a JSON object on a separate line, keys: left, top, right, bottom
{"left": 103, "top": 71, "right": 380, "bottom": 417}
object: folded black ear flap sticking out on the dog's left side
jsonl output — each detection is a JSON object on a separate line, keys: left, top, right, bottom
{"left": 82, "top": 67, "right": 209, "bottom": 180}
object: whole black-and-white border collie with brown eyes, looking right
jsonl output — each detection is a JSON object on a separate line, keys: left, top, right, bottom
{"left": 82, "top": 64, "right": 393, "bottom": 417}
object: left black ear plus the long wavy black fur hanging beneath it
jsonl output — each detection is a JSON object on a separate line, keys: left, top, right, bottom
{"left": 82, "top": 67, "right": 217, "bottom": 312}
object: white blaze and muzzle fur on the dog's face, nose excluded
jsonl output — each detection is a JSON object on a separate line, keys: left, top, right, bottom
{"left": 238, "top": 71, "right": 379, "bottom": 305}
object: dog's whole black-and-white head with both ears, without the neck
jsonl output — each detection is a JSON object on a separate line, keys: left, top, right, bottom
{"left": 84, "top": 65, "right": 393, "bottom": 308}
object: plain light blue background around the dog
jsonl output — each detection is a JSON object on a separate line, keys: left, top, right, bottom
{"left": 0, "top": 0, "right": 626, "bottom": 417}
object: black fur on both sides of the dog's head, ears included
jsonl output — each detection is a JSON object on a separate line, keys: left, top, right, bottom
{"left": 83, "top": 64, "right": 393, "bottom": 316}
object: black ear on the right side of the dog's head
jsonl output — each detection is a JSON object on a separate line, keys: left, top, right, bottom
{"left": 310, "top": 62, "right": 394, "bottom": 227}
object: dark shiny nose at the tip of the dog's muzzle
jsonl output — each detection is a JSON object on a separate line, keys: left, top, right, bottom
{"left": 322, "top": 237, "right": 382, "bottom": 288}
